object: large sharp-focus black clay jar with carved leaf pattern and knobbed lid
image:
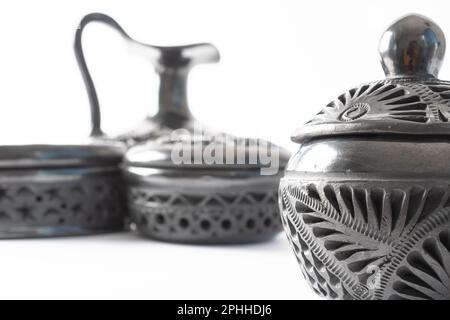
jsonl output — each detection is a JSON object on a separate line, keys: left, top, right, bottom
{"left": 279, "top": 15, "right": 450, "bottom": 300}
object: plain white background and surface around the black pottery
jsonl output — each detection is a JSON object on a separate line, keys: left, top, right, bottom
{"left": 0, "top": 0, "right": 450, "bottom": 299}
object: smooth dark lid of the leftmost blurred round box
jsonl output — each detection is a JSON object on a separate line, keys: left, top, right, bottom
{"left": 0, "top": 140, "right": 125, "bottom": 170}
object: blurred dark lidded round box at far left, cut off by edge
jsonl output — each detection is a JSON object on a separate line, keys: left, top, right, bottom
{"left": 0, "top": 140, "right": 127, "bottom": 238}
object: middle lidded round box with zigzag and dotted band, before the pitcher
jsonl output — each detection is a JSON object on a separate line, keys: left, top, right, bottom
{"left": 123, "top": 136, "right": 282, "bottom": 243}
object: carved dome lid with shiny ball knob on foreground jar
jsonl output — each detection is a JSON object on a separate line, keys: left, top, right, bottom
{"left": 292, "top": 14, "right": 450, "bottom": 143}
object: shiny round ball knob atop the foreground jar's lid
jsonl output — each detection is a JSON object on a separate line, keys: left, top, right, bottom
{"left": 379, "top": 14, "right": 445, "bottom": 78}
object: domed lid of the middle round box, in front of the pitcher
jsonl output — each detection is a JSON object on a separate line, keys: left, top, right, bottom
{"left": 124, "top": 132, "right": 290, "bottom": 172}
